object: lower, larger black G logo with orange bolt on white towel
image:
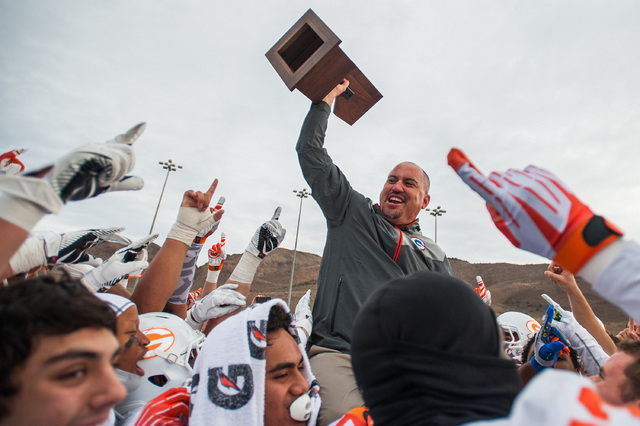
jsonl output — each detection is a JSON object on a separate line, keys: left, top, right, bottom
{"left": 207, "top": 364, "right": 253, "bottom": 410}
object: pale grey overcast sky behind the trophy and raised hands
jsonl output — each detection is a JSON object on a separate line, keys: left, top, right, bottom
{"left": 0, "top": 0, "right": 640, "bottom": 270}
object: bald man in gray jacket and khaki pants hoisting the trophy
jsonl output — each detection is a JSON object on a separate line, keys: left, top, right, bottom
{"left": 296, "top": 79, "right": 452, "bottom": 425}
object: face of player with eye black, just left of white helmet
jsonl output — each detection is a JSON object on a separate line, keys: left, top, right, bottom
{"left": 116, "top": 306, "right": 150, "bottom": 376}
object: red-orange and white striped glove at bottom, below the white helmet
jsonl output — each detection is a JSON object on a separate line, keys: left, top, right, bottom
{"left": 136, "top": 387, "right": 191, "bottom": 426}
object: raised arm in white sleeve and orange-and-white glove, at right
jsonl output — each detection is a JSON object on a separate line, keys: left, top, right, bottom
{"left": 448, "top": 148, "right": 640, "bottom": 320}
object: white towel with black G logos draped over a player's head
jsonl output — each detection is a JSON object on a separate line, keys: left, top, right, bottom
{"left": 189, "top": 299, "right": 320, "bottom": 426}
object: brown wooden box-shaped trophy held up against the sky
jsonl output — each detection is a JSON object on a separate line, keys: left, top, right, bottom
{"left": 266, "top": 9, "right": 382, "bottom": 125}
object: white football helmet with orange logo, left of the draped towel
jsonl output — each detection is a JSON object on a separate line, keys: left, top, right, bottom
{"left": 116, "top": 312, "right": 205, "bottom": 416}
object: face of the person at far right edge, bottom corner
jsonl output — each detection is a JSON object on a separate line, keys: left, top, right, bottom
{"left": 591, "top": 351, "right": 638, "bottom": 405}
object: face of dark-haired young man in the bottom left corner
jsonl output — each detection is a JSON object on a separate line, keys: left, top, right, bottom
{"left": 5, "top": 328, "right": 126, "bottom": 426}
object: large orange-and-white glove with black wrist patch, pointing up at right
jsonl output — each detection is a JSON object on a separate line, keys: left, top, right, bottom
{"left": 447, "top": 148, "right": 622, "bottom": 274}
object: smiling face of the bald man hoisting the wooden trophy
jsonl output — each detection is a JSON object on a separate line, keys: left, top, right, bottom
{"left": 380, "top": 163, "right": 431, "bottom": 226}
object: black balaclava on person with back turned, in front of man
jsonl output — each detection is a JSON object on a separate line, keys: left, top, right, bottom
{"left": 351, "top": 272, "right": 521, "bottom": 426}
